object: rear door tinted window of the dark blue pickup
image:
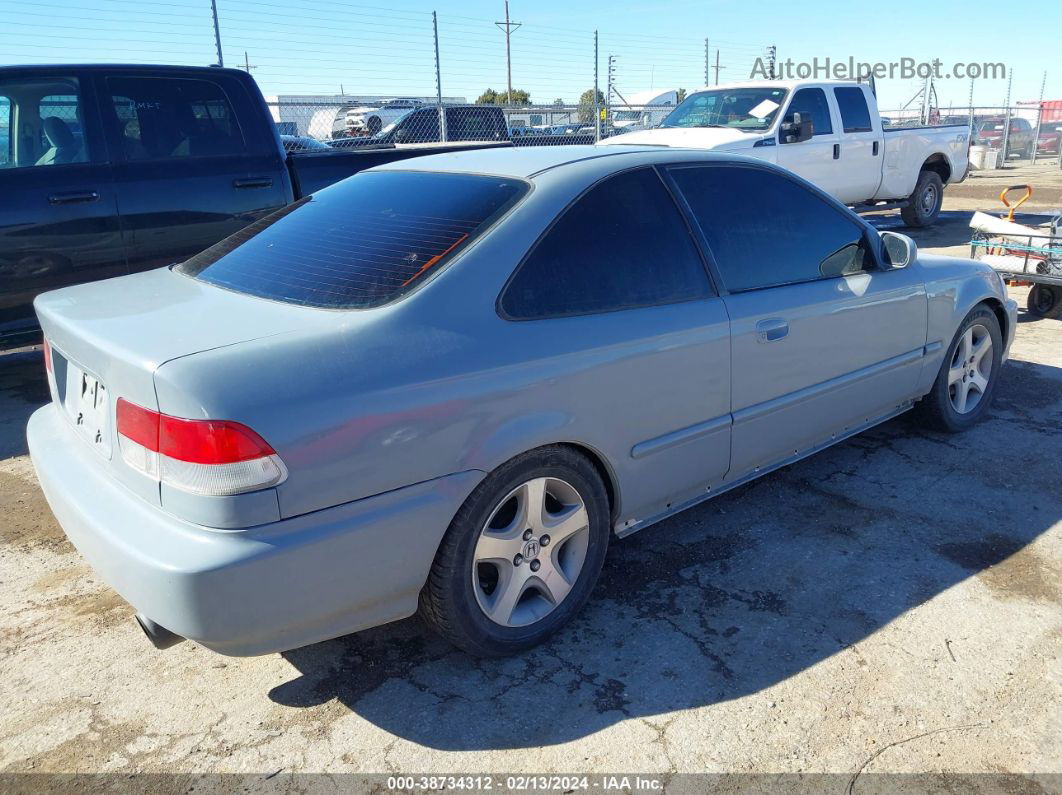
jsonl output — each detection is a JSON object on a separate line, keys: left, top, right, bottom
{"left": 107, "top": 77, "right": 244, "bottom": 160}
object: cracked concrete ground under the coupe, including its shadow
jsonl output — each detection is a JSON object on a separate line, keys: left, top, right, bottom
{"left": 0, "top": 191, "right": 1062, "bottom": 792}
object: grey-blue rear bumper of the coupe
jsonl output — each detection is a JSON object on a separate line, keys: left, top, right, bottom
{"left": 27, "top": 404, "right": 482, "bottom": 656}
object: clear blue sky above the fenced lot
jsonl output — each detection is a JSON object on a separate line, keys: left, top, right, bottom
{"left": 0, "top": 0, "right": 1062, "bottom": 108}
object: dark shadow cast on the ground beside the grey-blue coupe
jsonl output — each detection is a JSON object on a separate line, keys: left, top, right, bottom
{"left": 270, "top": 362, "right": 1062, "bottom": 750}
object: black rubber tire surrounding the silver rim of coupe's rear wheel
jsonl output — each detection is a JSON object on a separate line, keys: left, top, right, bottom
{"left": 419, "top": 445, "right": 611, "bottom": 657}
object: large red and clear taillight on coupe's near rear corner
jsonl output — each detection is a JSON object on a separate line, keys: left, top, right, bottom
{"left": 116, "top": 398, "right": 286, "bottom": 496}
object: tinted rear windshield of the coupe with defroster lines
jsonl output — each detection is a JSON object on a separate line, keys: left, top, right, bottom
{"left": 176, "top": 171, "right": 528, "bottom": 309}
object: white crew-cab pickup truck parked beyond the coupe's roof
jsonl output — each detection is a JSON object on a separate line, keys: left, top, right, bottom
{"left": 598, "top": 81, "right": 970, "bottom": 226}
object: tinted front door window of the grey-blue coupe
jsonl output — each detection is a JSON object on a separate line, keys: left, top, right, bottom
{"left": 670, "top": 167, "right": 869, "bottom": 292}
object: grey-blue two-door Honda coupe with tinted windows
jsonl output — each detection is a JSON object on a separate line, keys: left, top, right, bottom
{"left": 28, "top": 146, "right": 1015, "bottom": 655}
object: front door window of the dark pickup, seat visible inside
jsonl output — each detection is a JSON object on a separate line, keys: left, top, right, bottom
{"left": 0, "top": 77, "right": 90, "bottom": 168}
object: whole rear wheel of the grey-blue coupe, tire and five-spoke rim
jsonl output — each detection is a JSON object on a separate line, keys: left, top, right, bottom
{"left": 421, "top": 445, "right": 611, "bottom": 657}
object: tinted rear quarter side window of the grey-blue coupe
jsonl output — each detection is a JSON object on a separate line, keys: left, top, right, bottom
{"left": 501, "top": 169, "right": 712, "bottom": 319}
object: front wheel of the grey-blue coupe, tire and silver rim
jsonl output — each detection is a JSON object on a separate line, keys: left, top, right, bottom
{"left": 915, "top": 304, "right": 1003, "bottom": 433}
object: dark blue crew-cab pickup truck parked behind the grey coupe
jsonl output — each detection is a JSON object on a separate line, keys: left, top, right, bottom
{"left": 0, "top": 65, "right": 514, "bottom": 347}
